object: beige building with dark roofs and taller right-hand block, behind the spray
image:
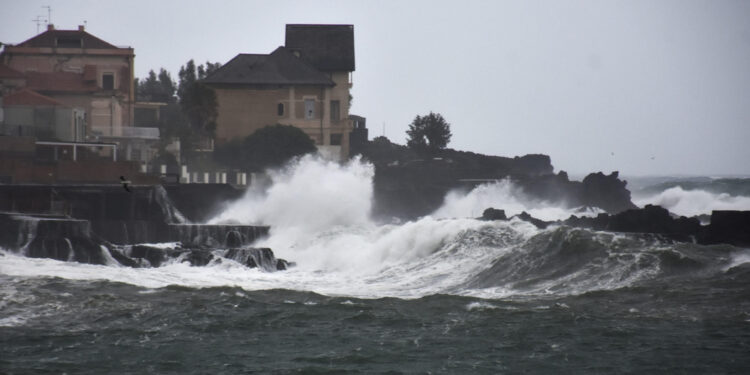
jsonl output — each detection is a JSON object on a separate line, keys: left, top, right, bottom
{"left": 204, "top": 25, "right": 354, "bottom": 159}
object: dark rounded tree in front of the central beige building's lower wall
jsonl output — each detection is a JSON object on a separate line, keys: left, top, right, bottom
{"left": 214, "top": 124, "right": 317, "bottom": 171}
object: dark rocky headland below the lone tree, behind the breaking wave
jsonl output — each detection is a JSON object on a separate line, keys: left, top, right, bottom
{"left": 363, "top": 137, "right": 636, "bottom": 220}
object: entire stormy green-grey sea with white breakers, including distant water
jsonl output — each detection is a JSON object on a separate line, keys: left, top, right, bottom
{"left": 0, "top": 158, "right": 750, "bottom": 374}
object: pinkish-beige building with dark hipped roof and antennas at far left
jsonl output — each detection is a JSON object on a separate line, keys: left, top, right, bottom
{"left": 0, "top": 24, "right": 135, "bottom": 140}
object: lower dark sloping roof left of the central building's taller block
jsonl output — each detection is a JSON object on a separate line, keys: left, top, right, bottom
{"left": 203, "top": 47, "right": 334, "bottom": 86}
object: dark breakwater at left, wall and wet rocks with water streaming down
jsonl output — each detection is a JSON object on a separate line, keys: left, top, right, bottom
{"left": 0, "top": 185, "right": 288, "bottom": 270}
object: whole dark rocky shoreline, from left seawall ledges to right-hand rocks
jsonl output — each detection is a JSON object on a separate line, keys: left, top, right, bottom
{"left": 0, "top": 145, "right": 750, "bottom": 271}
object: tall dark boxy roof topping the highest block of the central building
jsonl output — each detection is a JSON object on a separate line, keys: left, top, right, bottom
{"left": 285, "top": 25, "right": 354, "bottom": 72}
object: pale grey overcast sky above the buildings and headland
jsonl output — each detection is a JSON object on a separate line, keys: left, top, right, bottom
{"left": 0, "top": 0, "right": 750, "bottom": 175}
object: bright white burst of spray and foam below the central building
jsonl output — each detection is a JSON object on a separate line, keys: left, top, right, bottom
{"left": 212, "top": 156, "right": 520, "bottom": 280}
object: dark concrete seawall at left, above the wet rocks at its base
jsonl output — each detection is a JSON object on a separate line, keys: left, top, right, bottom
{"left": 0, "top": 184, "right": 256, "bottom": 244}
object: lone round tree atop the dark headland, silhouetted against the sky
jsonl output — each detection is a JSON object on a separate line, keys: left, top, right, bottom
{"left": 406, "top": 112, "right": 453, "bottom": 153}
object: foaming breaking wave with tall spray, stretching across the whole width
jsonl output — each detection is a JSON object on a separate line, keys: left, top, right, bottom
{"left": 0, "top": 157, "right": 750, "bottom": 298}
